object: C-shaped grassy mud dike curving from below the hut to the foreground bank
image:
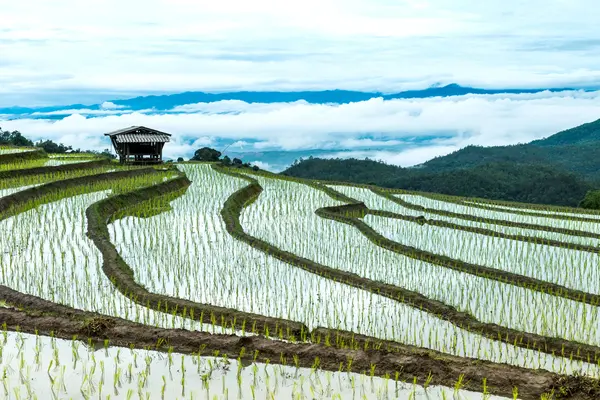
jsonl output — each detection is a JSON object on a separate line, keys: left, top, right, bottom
{"left": 86, "top": 176, "right": 309, "bottom": 340}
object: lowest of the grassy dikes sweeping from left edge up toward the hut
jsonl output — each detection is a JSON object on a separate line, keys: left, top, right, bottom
{"left": 0, "top": 168, "right": 157, "bottom": 220}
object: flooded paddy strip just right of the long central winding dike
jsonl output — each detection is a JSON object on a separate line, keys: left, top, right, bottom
{"left": 242, "top": 177, "right": 600, "bottom": 345}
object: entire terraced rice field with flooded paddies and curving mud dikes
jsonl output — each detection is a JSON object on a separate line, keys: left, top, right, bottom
{"left": 0, "top": 149, "right": 600, "bottom": 400}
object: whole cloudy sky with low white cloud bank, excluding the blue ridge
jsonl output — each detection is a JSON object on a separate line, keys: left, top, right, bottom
{"left": 0, "top": 0, "right": 600, "bottom": 166}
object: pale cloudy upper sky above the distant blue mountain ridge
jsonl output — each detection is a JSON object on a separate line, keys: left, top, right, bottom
{"left": 0, "top": 0, "right": 600, "bottom": 104}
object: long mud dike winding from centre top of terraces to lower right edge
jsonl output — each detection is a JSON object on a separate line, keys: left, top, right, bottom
{"left": 216, "top": 167, "right": 600, "bottom": 363}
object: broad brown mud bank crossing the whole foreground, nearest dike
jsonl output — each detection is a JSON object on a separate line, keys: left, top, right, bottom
{"left": 0, "top": 296, "right": 600, "bottom": 400}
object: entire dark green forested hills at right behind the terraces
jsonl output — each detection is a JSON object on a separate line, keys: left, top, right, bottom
{"left": 282, "top": 120, "right": 600, "bottom": 206}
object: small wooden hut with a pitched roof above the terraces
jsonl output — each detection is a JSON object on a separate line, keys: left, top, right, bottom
{"left": 104, "top": 126, "right": 171, "bottom": 164}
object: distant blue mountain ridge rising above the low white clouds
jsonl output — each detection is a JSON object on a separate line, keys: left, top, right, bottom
{"left": 0, "top": 84, "right": 580, "bottom": 115}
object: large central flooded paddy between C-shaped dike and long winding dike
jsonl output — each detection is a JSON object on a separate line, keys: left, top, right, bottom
{"left": 105, "top": 165, "right": 593, "bottom": 373}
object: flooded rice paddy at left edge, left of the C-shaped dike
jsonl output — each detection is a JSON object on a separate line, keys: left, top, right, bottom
{"left": 0, "top": 172, "right": 218, "bottom": 329}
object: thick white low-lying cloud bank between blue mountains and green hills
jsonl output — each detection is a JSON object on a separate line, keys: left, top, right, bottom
{"left": 0, "top": 91, "right": 600, "bottom": 166}
